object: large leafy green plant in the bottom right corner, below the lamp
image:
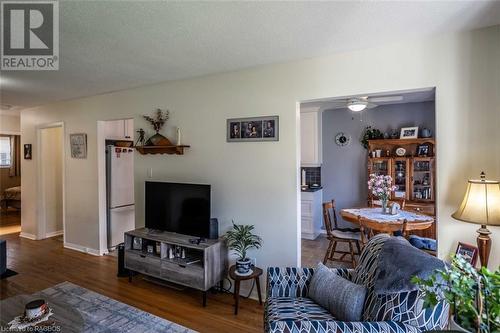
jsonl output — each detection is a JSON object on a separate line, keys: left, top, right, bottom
{"left": 412, "top": 255, "right": 500, "bottom": 333}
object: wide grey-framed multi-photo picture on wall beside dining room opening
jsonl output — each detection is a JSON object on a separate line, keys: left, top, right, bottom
{"left": 226, "top": 116, "right": 279, "bottom": 142}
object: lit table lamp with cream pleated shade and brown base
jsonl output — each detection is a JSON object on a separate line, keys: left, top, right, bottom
{"left": 451, "top": 172, "right": 500, "bottom": 267}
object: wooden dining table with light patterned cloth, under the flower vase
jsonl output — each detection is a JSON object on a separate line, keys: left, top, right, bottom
{"left": 340, "top": 207, "right": 435, "bottom": 241}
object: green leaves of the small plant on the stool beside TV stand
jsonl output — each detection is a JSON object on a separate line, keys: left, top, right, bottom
{"left": 224, "top": 221, "right": 262, "bottom": 260}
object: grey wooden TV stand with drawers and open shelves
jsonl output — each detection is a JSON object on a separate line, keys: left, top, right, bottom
{"left": 125, "top": 228, "right": 227, "bottom": 306}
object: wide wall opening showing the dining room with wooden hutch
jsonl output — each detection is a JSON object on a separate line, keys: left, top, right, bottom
{"left": 300, "top": 88, "right": 437, "bottom": 267}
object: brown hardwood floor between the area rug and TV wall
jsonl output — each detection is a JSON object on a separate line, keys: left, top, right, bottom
{"left": 0, "top": 234, "right": 263, "bottom": 333}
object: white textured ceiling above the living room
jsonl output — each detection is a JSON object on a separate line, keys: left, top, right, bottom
{"left": 0, "top": 1, "right": 500, "bottom": 109}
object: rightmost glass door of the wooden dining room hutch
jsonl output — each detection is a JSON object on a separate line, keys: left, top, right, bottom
{"left": 411, "top": 158, "right": 434, "bottom": 201}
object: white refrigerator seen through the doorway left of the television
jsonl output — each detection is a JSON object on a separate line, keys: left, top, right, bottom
{"left": 106, "top": 145, "right": 135, "bottom": 250}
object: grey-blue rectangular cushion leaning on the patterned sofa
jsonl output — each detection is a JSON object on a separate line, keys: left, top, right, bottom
{"left": 309, "top": 263, "right": 366, "bottom": 321}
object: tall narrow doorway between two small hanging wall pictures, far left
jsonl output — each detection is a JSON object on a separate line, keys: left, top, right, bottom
{"left": 37, "top": 123, "right": 65, "bottom": 240}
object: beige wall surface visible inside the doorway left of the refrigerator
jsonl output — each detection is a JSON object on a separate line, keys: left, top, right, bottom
{"left": 40, "top": 127, "right": 63, "bottom": 236}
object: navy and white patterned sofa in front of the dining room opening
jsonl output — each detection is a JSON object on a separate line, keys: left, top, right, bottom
{"left": 264, "top": 234, "right": 449, "bottom": 333}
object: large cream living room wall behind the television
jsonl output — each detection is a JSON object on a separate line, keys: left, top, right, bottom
{"left": 21, "top": 26, "right": 500, "bottom": 267}
